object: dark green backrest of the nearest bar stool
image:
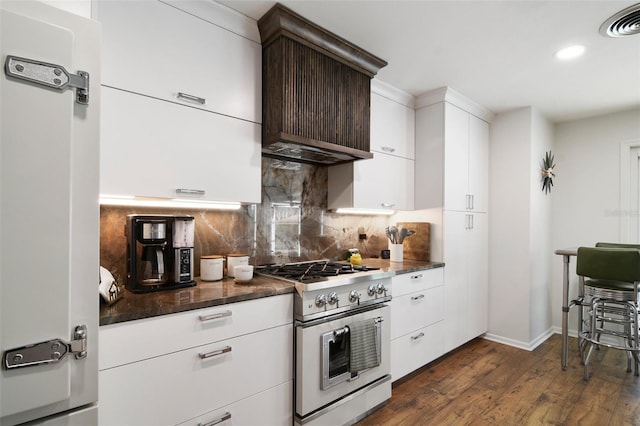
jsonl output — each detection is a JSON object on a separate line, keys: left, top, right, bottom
{"left": 576, "top": 246, "right": 640, "bottom": 283}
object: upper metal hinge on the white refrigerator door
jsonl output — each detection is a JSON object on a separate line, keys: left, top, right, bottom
{"left": 4, "top": 55, "right": 89, "bottom": 105}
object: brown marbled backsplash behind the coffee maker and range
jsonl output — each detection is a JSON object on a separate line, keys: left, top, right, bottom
{"left": 100, "top": 158, "right": 389, "bottom": 277}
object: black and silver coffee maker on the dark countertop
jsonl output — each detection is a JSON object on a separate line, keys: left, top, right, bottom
{"left": 125, "top": 215, "right": 196, "bottom": 293}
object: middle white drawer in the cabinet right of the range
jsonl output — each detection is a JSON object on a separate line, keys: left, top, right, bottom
{"left": 391, "top": 286, "right": 444, "bottom": 339}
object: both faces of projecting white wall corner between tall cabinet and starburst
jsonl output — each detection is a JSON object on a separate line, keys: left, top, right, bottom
{"left": 487, "top": 107, "right": 553, "bottom": 349}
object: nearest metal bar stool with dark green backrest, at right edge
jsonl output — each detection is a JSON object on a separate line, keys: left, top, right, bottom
{"left": 576, "top": 246, "right": 640, "bottom": 380}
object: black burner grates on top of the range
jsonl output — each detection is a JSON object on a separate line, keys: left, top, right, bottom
{"left": 258, "top": 261, "right": 379, "bottom": 282}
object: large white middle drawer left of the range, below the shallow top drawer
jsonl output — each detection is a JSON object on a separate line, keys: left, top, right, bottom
{"left": 99, "top": 325, "right": 293, "bottom": 426}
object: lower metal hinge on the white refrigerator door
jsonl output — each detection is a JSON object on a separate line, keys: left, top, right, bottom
{"left": 2, "top": 325, "right": 87, "bottom": 370}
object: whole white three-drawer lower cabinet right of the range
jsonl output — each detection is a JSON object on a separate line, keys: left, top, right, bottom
{"left": 391, "top": 268, "right": 444, "bottom": 381}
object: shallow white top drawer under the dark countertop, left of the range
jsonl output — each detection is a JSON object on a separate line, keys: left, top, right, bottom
{"left": 99, "top": 294, "right": 293, "bottom": 370}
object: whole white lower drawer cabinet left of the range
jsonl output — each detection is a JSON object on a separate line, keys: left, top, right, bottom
{"left": 98, "top": 295, "right": 293, "bottom": 426}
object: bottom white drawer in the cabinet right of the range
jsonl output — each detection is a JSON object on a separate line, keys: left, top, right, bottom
{"left": 391, "top": 321, "right": 443, "bottom": 381}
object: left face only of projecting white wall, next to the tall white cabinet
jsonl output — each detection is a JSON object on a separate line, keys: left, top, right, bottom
{"left": 488, "top": 108, "right": 531, "bottom": 347}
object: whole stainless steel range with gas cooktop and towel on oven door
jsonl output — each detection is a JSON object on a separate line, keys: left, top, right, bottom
{"left": 257, "top": 261, "right": 393, "bottom": 425}
